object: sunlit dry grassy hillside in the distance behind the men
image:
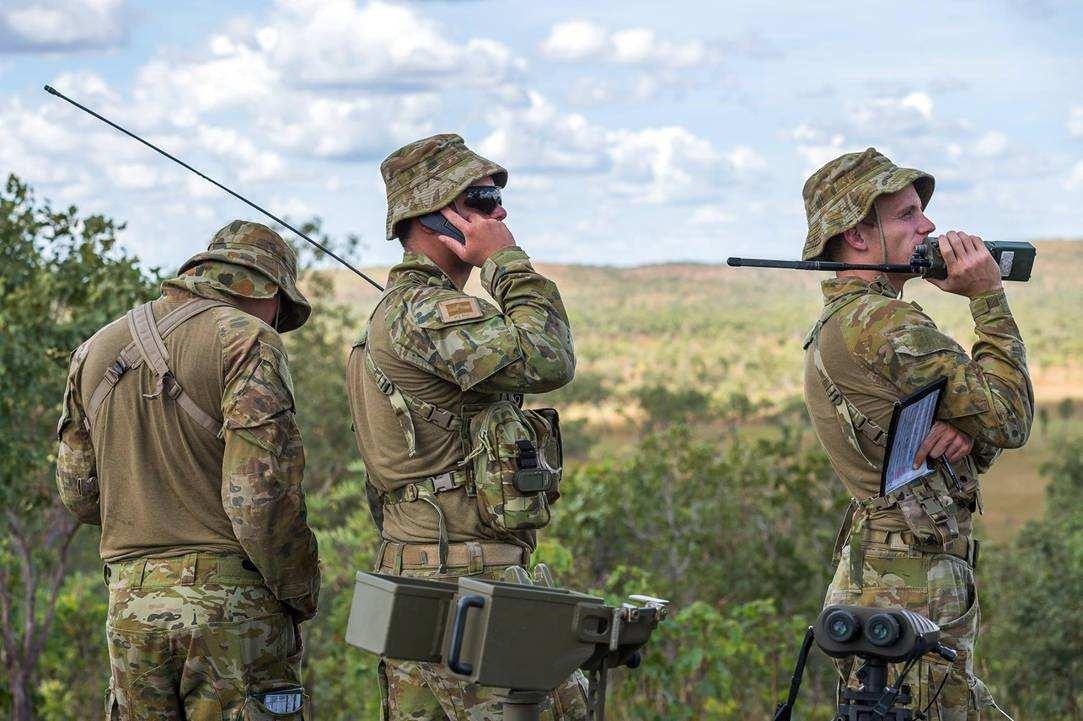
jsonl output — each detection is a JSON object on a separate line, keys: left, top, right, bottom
{"left": 322, "top": 240, "right": 1083, "bottom": 538}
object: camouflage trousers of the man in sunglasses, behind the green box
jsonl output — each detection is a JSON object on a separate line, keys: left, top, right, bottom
{"left": 378, "top": 547, "right": 587, "bottom": 721}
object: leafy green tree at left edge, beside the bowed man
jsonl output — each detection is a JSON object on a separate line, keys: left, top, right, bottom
{"left": 0, "top": 175, "right": 156, "bottom": 721}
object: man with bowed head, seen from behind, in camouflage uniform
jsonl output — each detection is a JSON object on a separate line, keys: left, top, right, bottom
{"left": 56, "top": 221, "right": 319, "bottom": 721}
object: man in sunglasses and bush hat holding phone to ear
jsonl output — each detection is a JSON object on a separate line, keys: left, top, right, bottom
{"left": 347, "top": 134, "right": 586, "bottom": 721}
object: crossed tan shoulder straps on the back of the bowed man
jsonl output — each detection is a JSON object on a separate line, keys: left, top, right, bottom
{"left": 86, "top": 298, "right": 229, "bottom": 435}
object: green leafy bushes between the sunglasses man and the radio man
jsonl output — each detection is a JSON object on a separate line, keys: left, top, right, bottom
{"left": 550, "top": 422, "right": 845, "bottom": 721}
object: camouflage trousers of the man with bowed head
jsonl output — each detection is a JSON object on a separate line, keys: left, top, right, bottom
{"left": 105, "top": 553, "right": 308, "bottom": 721}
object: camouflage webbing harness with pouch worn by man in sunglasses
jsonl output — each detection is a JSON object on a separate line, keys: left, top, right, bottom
{"left": 354, "top": 286, "right": 562, "bottom": 573}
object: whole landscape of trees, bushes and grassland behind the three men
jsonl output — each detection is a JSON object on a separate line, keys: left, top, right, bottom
{"left": 0, "top": 179, "right": 1083, "bottom": 721}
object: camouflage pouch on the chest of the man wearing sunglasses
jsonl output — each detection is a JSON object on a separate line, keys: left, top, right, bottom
{"left": 470, "top": 399, "right": 562, "bottom": 530}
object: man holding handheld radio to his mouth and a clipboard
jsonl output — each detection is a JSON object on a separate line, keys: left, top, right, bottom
{"left": 801, "top": 148, "right": 1034, "bottom": 721}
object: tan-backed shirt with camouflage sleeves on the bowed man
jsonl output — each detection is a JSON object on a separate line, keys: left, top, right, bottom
{"left": 56, "top": 276, "right": 319, "bottom": 618}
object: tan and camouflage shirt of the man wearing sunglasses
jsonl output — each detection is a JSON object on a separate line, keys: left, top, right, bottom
{"left": 347, "top": 247, "right": 575, "bottom": 546}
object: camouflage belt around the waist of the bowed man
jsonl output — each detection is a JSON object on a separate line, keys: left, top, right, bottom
{"left": 102, "top": 552, "right": 263, "bottom": 588}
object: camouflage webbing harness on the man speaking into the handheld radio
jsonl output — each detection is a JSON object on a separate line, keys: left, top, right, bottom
{"left": 803, "top": 293, "right": 980, "bottom": 549}
